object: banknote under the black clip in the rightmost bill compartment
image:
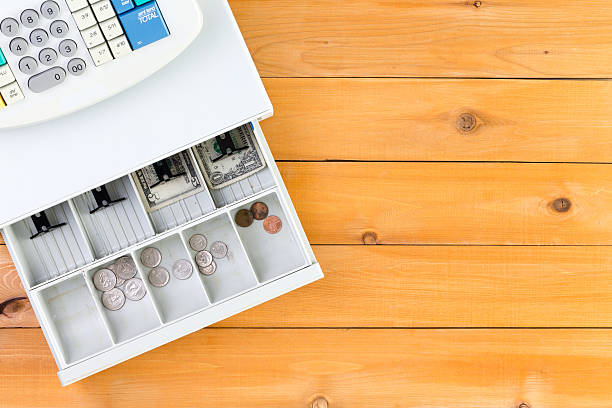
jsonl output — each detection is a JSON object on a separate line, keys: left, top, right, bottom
{"left": 193, "top": 124, "right": 266, "bottom": 189}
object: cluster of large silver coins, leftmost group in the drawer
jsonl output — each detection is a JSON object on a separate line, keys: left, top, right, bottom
{"left": 92, "top": 256, "right": 147, "bottom": 311}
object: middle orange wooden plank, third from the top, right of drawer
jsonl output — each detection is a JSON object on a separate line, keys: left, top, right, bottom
{"left": 279, "top": 163, "right": 612, "bottom": 245}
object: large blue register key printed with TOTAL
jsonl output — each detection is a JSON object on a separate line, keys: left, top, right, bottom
{"left": 119, "top": 1, "right": 170, "bottom": 50}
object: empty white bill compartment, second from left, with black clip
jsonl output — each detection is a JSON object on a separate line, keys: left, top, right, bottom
{"left": 72, "top": 176, "right": 155, "bottom": 259}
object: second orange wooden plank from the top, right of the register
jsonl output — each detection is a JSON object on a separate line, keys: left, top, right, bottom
{"left": 262, "top": 78, "right": 612, "bottom": 162}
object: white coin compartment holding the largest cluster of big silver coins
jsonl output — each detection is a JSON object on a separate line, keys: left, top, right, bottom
{"left": 85, "top": 257, "right": 161, "bottom": 343}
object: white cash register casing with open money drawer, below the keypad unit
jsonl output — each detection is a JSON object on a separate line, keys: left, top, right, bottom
{"left": 0, "top": 0, "right": 323, "bottom": 385}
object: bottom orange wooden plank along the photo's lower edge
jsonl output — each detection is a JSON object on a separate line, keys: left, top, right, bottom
{"left": 0, "top": 329, "right": 612, "bottom": 408}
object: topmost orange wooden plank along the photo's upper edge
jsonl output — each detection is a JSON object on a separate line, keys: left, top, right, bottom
{"left": 230, "top": 0, "right": 612, "bottom": 78}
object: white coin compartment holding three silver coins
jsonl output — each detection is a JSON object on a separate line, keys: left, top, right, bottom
{"left": 134, "top": 234, "right": 210, "bottom": 323}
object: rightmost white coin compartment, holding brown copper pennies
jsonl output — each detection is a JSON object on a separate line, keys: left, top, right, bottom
{"left": 230, "top": 193, "right": 308, "bottom": 282}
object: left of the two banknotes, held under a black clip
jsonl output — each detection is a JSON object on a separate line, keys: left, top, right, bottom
{"left": 132, "top": 150, "right": 205, "bottom": 212}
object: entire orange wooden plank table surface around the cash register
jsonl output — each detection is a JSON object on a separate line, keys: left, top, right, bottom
{"left": 0, "top": 0, "right": 612, "bottom": 408}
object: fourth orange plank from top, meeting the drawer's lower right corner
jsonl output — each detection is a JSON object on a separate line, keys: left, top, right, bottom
{"left": 5, "top": 245, "right": 612, "bottom": 327}
